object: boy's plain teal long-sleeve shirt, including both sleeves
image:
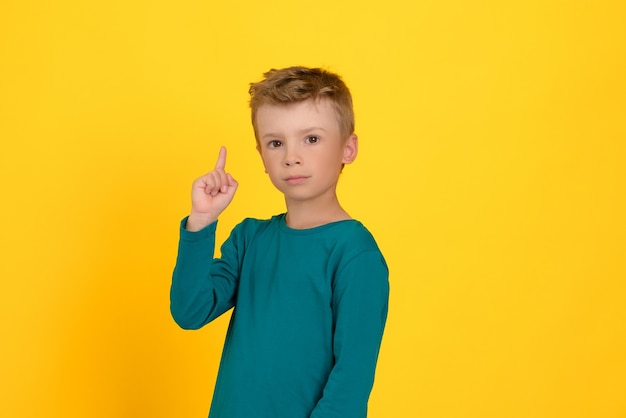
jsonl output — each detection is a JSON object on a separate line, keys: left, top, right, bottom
{"left": 170, "top": 214, "right": 389, "bottom": 418}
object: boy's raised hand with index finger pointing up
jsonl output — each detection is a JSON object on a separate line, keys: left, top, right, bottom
{"left": 186, "top": 147, "right": 238, "bottom": 231}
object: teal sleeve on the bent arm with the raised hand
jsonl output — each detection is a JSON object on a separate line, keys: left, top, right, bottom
{"left": 170, "top": 218, "right": 239, "bottom": 329}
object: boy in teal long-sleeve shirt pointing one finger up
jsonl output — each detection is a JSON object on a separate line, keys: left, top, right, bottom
{"left": 170, "top": 67, "right": 389, "bottom": 418}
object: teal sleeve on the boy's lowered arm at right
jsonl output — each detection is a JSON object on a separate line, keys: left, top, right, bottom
{"left": 311, "top": 251, "right": 389, "bottom": 418}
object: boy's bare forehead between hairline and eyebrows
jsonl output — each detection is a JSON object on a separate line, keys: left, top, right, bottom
{"left": 256, "top": 98, "right": 339, "bottom": 135}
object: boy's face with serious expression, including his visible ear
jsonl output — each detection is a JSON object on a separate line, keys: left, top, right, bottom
{"left": 256, "top": 98, "right": 358, "bottom": 203}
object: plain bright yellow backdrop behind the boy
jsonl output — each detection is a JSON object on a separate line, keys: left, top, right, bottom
{"left": 0, "top": 0, "right": 626, "bottom": 418}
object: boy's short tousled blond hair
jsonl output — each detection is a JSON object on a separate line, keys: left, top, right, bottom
{"left": 249, "top": 67, "right": 354, "bottom": 139}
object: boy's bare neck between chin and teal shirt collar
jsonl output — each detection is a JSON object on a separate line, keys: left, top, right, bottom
{"left": 285, "top": 195, "right": 352, "bottom": 229}
